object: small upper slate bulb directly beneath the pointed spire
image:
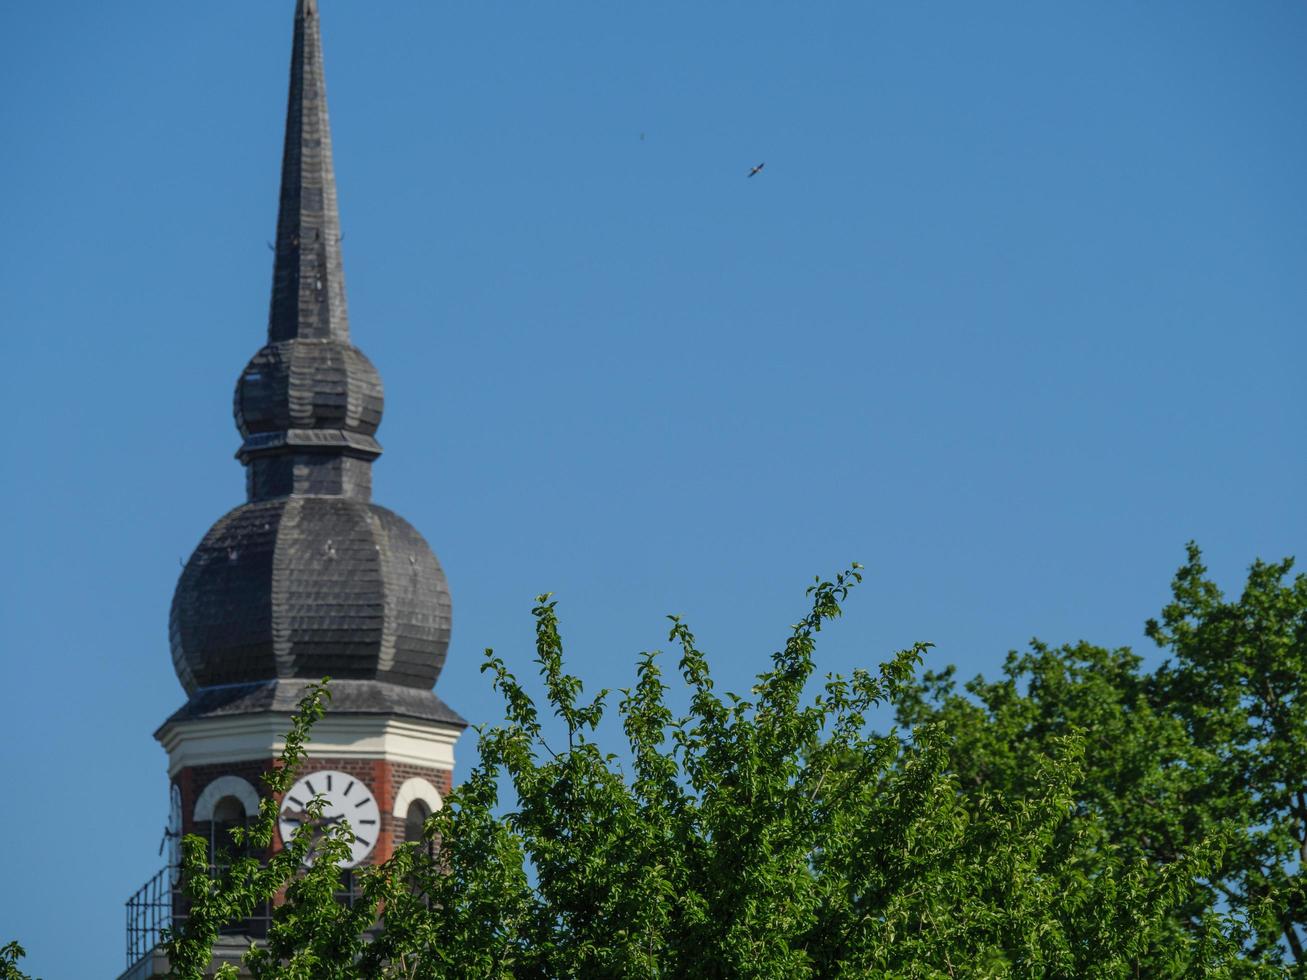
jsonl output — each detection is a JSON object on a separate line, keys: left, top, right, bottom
{"left": 234, "top": 338, "right": 384, "bottom": 438}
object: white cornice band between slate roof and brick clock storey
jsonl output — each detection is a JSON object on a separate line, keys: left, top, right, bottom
{"left": 156, "top": 712, "right": 463, "bottom": 776}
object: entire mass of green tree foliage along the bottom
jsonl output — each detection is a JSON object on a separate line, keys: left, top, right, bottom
{"left": 0, "top": 546, "right": 1307, "bottom": 980}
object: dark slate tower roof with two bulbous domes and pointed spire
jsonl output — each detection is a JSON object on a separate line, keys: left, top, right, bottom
{"left": 169, "top": 0, "right": 457, "bottom": 720}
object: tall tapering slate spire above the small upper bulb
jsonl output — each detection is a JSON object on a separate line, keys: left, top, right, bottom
{"left": 268, "top": 0, "right": 349, "bottom": 344}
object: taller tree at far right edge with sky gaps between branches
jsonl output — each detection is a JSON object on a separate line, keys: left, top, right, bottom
{"left": 1148, "top": 544, "right": 1307, "bottom": 972}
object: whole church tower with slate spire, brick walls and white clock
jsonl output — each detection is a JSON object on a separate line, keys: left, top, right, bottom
{"left": 128, "top": 0, "right": 465, "bottom": 959}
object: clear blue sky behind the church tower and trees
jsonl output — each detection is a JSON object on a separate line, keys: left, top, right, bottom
{"left": 0, "top": 0, "right": 1307, "bottom": 977}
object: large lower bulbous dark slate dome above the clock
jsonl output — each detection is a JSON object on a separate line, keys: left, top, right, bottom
{"left": 169, "top": 495, "right": 451, "bottom": 695}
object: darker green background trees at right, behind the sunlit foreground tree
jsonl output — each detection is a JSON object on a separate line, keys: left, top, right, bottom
{"left": 898, "top": 545, "right": 1307, "bottom": 976}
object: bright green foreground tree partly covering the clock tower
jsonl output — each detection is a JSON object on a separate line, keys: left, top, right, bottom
{"left": 170, "top": 566, "right": 1233, "bottom": 979}
